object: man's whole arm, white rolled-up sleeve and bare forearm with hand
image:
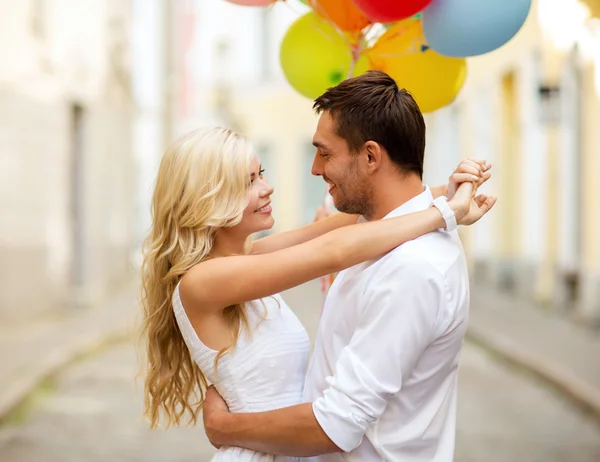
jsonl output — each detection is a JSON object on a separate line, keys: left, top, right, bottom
{"left": 204, "top": 259, "right": 444, "bottom": 457}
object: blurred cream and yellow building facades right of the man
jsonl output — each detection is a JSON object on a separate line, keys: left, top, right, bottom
{"left": 428, "top": 0, "right": 600, "bottom": 323}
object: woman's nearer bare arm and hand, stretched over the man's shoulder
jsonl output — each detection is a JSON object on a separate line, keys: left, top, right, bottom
{"left": 181, "top": 183, "right": 493, "bottom": 312}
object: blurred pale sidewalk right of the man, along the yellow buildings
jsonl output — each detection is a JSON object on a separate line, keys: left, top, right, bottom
{"left": 467, "top": 286, "right": 600, "bottom": 421}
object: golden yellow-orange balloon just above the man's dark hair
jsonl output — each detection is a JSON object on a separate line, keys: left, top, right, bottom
{"left": 368, "top": 19, "right": 467, "bottom": 112}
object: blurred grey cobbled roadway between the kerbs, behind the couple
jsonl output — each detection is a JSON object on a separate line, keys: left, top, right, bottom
{"left": 0, "top": 282, "right": 600, "bottom": 462}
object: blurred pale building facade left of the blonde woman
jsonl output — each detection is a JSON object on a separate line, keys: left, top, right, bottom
{"left": 0, "top": 0, "right": 135, "bottom": 320}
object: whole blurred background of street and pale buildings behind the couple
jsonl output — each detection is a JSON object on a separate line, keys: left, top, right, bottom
{"left": 0, "top": 0, "right": 600, "bottom": 462}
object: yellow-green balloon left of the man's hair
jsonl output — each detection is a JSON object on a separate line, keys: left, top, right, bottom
{"left": 279, "top": 11, "right": 369, "bottom": 99}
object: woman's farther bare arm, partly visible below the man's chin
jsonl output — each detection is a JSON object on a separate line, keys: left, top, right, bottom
{"left": 252, "top": 213, "right": 358, "bottom": 255}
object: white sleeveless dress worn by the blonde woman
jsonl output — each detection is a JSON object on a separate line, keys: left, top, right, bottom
{"left": 173, "top": 285, "right": 310, "bottom": 462}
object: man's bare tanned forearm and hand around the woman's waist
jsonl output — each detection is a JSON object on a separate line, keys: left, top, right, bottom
{"left": 204, "top": 398, "right": 341, "bottom": 457}
